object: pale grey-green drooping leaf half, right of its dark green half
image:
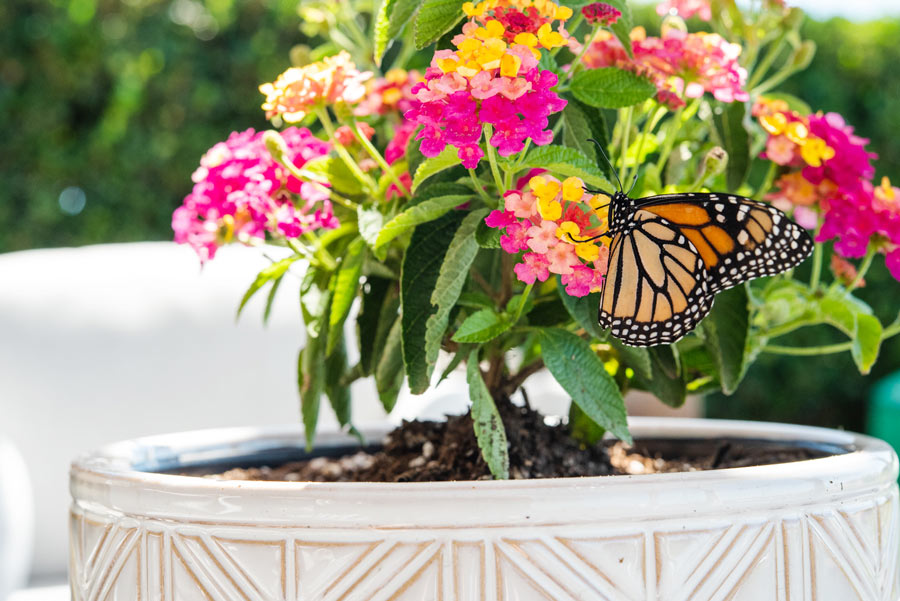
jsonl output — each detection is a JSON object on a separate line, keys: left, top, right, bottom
{"left": 425, "top": 209, "right": 489, "bottom": 365}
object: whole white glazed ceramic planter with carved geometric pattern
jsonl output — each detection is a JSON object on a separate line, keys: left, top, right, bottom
{"left": 70, "top": 418, "right": 900, "bottom": 601}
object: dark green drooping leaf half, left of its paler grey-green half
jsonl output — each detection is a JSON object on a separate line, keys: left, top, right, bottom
{"left": 400, "top": 211, "right": 466, "bottom": 394}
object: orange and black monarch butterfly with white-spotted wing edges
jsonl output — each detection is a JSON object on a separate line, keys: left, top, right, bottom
{"left": 586, "top": 146, "right": 813, "bottom": 346}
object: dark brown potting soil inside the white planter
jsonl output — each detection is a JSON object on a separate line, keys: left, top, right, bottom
{"left": 197, "top": 405, "right": 829, "bottom": 482}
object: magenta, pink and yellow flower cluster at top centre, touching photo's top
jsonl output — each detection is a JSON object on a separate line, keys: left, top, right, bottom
{"left": 406, "top": 0, "right": 572, "bottom": 169}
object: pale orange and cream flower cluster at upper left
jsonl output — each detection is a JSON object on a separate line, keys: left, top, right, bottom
{"left": 259, "top": 51, "right": 372, "bottom": 123}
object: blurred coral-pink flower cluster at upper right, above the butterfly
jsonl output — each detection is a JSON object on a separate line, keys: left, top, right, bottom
{"left": 584, "top": 27, "right": 750, "bottom": 108}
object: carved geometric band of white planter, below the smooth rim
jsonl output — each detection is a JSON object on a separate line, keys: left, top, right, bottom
{"left": 71, "top": 489, "right": 900, "bottom": 601}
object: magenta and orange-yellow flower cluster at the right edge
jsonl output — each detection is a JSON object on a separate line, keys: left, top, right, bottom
{"left": 753, "top": 100, "right": 900, "bottom": 280}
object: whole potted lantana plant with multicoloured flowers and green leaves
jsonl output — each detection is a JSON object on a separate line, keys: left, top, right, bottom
{"left": 172, "top": 0, "right": 900, "bottom": 478}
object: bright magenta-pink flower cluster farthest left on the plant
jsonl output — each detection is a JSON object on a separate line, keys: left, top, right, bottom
{"left": 172, "top": 127, "right": 338, "bottom": 261}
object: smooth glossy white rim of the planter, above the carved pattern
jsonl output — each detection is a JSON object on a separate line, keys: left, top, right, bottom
{"left": 70, "top": 418, "right": 898, "bottom": 528}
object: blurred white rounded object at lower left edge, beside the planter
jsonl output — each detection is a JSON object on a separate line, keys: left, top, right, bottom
{"left": 0, "top": 436, "right": 34, "bottom": 601}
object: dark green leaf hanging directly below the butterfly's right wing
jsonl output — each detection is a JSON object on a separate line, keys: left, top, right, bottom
{"left": 701, "top": 286, "right": 750, "bottom": 395}
